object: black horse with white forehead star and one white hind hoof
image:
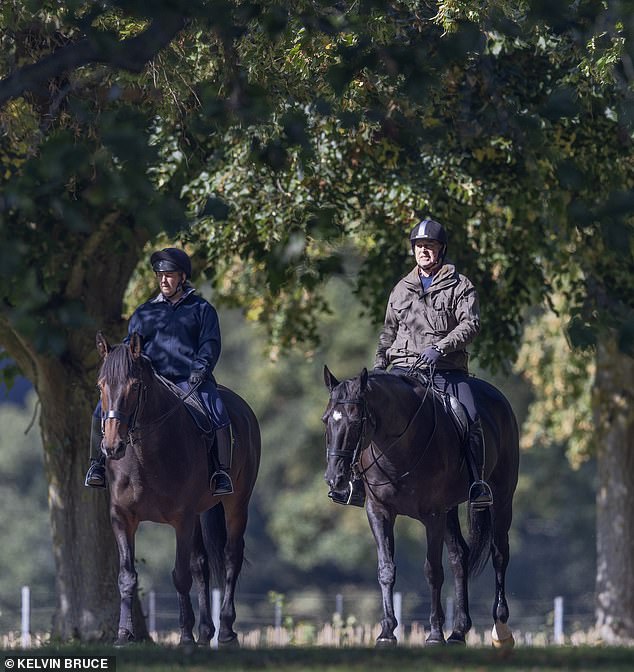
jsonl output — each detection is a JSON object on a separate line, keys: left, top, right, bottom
{"left": 323, "top": 367, "right": 519, "bottom": 646}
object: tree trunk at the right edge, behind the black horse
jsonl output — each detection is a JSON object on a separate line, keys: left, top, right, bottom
{"left": 593, "top": 342, "right": 634, "bottom": 643}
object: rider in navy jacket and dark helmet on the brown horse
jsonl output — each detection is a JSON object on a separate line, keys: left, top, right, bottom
{"left": 85, "top": 247, "right": 233, "bottom": 495}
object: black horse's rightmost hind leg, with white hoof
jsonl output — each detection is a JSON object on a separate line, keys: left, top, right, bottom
{"left": 491, "top": 503, "right": 515, "bottom": 648}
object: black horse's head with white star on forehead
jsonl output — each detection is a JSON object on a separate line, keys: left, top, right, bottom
{"left": 322, "top": 366, "right": 369, "bottom": 501}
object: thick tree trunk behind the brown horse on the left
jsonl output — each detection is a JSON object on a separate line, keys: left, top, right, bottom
{"left": 37, "top": 352, "right": 147, "bottom": 641}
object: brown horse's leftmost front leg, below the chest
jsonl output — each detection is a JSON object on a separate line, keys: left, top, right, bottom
{"left": 110, "top": 508, "right": 139, "bottom": 646}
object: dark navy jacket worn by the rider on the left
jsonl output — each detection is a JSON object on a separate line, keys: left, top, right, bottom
{"left": 128, "top": 287, "right": 221, "bottom": 383}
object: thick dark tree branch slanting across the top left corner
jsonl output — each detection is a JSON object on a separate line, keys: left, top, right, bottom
{"left": 0, "top": 13, "right": 185, "bottom": 107}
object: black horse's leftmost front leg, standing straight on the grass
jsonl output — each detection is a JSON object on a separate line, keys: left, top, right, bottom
{"left": 366, "top": 500, "right": 398, "bottom": 646}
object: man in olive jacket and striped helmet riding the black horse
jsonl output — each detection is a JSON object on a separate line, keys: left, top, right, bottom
{"left": 338, "top": 219, "right": 492, "bottom": 509}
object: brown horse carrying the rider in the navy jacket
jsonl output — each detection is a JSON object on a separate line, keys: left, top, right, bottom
{"left": 97, "top": 333, "right": 260, "bottom": 645}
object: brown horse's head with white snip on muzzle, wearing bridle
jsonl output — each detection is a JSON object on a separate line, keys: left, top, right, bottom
{"left": 97, "top": 332, "right": 145, "bottom": 460}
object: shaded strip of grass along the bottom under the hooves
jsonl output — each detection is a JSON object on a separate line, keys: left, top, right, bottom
{"left": 5, "top": 644, "right": 634, "bottom": 672}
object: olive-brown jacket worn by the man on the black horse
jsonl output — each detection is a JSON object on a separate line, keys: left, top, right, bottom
{"left": 374, "top": 264, "right": 480, "bottom": 371}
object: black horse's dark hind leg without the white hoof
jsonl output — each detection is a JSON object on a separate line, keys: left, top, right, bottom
{"left": 445, "top": 507, "right": 471, "bottom": 644}
